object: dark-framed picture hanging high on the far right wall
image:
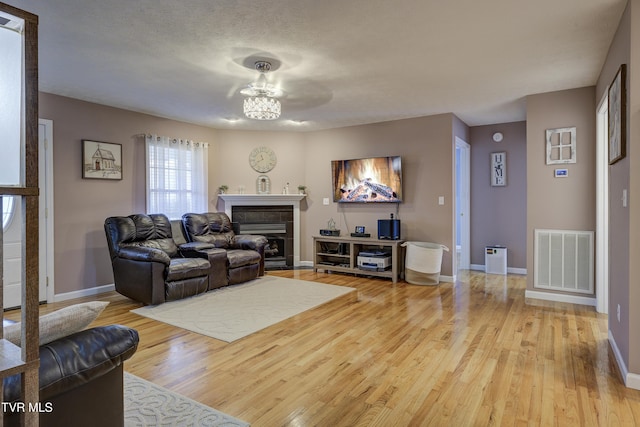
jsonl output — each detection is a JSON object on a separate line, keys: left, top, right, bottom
{"left": 608, "top": 64, "right": 627, "bottom": 165}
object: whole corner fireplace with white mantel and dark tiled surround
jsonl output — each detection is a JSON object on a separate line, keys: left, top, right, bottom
{"left": 219, "top": 194, "right": 305, "bottom": 268}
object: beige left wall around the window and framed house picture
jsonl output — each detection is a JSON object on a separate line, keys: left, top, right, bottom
{"left": 39, "top": 93, "right": 216, "bottom": 294}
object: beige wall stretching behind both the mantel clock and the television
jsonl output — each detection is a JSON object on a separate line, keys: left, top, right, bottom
{"left": 216, "top": 114, "right": 466, "bottom": 275}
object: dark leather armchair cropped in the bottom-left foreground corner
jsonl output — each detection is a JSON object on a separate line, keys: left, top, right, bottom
{"left": 3, "top": 325, "right": 139, "bottom": 427}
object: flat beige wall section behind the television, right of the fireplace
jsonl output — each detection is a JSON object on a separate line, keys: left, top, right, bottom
{"left": 303, "top": 114, "right": 454, "bottom": 275}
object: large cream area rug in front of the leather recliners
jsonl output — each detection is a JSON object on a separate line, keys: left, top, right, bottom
{"left": 131, "top": 275, "right": 356, "bottom": 342}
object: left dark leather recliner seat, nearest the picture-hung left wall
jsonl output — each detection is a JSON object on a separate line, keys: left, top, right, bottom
{"left": 104, "top": 214, "right": 211, "bottom": 305}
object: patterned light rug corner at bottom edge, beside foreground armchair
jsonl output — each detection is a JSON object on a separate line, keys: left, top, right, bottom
{"left": 124, "top": 372, "right": 249, "bottom": 427}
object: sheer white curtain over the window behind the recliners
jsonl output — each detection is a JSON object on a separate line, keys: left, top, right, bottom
{"left": 145, "top": 135, "right": 209, "bottom": 219}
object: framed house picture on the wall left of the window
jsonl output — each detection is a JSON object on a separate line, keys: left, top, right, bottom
{"left": 82, "top": 139, "right": 122, "bottom": 180}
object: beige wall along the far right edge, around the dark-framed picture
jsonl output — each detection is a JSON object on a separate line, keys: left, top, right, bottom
{"left": 596, "top": 0, "right": 640, "bottom": 382}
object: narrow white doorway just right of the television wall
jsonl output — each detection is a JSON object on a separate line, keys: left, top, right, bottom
{"left": 454, "top": 137, "right": 471, "bottom": 271}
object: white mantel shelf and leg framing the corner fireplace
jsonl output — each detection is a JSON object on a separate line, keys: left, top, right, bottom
{"left": 218, "top": 194, "right": 306, "bottom": 266}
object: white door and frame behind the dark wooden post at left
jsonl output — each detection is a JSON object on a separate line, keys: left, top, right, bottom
{"left": 3, "top": 120, "right": 53, "bottom": 308}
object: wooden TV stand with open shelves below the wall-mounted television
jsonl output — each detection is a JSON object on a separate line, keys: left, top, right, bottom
{"left": 313, "top": 236, "right": 404, "bottom": 283}
